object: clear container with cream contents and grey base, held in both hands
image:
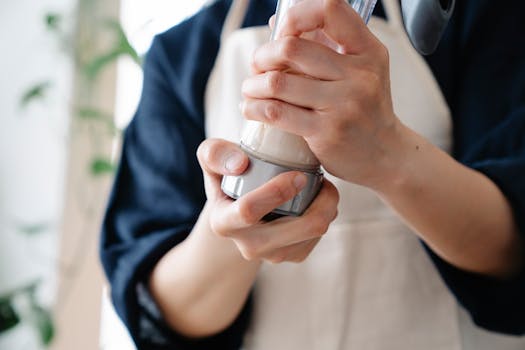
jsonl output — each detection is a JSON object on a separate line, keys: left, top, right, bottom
{"left": 221, "top": 0, "right": 376, "bottom": 215}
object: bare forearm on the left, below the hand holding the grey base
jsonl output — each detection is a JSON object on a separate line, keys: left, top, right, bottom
{"left": 150, "top": 207, "right": 259, "bottom": 337}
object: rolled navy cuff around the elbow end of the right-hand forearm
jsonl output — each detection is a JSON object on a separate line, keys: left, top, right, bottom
{"left": 424, "top": 107, "right": 525, "bottom": 335}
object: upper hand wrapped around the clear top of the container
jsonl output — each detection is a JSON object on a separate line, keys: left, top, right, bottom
{"left": 242, "top": 0, "right": 402, "bottom": 191}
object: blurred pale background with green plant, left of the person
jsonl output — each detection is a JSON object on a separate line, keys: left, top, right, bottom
{"left": 0, "top": 0, "right": 206, "bottom": 350}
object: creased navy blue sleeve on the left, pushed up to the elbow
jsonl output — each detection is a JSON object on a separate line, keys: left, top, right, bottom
{"left": 100, "top": 1, "right": 254, "bottom": 350}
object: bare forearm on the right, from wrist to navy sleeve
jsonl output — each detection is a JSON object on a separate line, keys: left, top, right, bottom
{"left": 378, "top": 126, "right": 523, "bottom": 278}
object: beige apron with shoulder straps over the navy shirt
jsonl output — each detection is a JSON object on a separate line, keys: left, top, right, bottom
{"left": 205, "top": 0, "right": 525, "bottom": 350}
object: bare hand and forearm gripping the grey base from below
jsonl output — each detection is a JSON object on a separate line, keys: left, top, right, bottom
{"left": 149, "top": 139, "right": 339, "bottom": 337}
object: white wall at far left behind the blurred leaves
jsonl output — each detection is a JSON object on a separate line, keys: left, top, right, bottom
{"left": 0, "top": 0, "right": 76, "bottom": 350}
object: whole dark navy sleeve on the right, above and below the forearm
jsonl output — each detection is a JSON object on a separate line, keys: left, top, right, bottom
{"left": 429, "top": 1, "right": 525, "bottom": 335}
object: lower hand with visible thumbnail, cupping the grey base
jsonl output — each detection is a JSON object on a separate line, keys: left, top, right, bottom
{"left": 197, "top": 139, "right": 339, "bottom": 263}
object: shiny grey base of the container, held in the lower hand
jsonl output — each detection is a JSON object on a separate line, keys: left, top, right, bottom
{"left": 221, "top": 152, "right": 323, "bottom": 216}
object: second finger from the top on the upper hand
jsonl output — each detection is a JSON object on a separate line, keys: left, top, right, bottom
{"left": 252, "top": 36, "right": 348, "bottom": 80}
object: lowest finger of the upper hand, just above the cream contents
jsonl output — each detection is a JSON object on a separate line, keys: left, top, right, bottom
{"left": 241, "top": 98, "right": 323, "bottom": 137}
